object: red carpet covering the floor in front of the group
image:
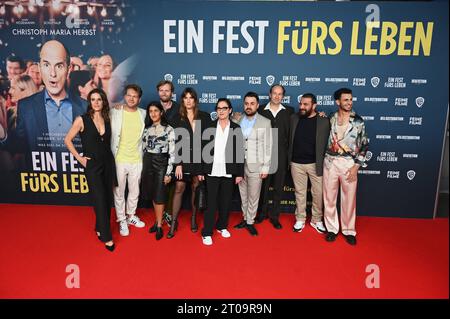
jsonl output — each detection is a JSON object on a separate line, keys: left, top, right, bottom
{"left": 0, "top": 204, "right": 449, "bottom": 299}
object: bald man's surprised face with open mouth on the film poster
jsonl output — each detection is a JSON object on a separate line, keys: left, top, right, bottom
{"left": 39, "top": 40, "right": 69, "bottom": 99}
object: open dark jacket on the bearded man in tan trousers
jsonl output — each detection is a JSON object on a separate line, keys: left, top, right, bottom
{"left": 288, "top": 113, "right": 330, "bottom": 176}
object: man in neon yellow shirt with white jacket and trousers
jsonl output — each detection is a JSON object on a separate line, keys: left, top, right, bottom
{"left": 111, "top": 84, "right": 146, "bottom": 236}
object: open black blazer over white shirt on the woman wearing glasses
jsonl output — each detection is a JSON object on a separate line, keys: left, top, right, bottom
{"left": 202, "top": 120, "right": 245, "bottom": 177}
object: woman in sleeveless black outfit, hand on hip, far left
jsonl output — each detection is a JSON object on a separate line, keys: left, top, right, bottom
{"left": 64, "top": 89, "right": 117, "bottom": 251}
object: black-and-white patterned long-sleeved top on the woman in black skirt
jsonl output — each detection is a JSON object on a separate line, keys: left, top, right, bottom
{"left": 142, "top": 124, "right": 175, "bottom": 175}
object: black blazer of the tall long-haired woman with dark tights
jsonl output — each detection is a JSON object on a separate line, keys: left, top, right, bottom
{"left": 172, "top": 110, "right": 211, "bottom": 175}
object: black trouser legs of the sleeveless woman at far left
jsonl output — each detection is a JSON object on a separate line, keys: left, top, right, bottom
{"left": 84, "top": 160, "right": 113, "bottom": 243}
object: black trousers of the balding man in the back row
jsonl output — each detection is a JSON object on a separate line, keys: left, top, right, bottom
{"left": 258, "top": 161, "right": 287, "bottom": 220}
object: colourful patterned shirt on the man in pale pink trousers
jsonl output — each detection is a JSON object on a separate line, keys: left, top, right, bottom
{"left": 326, "top": 111, "right": 369, "bottom": 167}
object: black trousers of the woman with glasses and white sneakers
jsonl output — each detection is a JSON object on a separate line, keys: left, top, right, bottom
{"left": 202, "top": 176, "right": 234, "bottom": 236}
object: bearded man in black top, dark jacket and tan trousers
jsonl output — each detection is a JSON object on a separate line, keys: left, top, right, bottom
{"left": 289, "top": 93, "right": 330, "bottom": 233}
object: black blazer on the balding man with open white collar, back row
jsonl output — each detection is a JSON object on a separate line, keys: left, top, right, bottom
{"left": 258, "top": 104, "right": 294, "bottom": 170}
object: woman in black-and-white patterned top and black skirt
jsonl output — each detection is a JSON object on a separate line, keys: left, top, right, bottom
{"left": 142, "top": 102, "right": 175, "bottom": 240}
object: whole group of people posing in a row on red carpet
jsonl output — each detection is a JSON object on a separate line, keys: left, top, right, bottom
{"left": 65, "top": 81, "right": 368, "bottom": 251}
